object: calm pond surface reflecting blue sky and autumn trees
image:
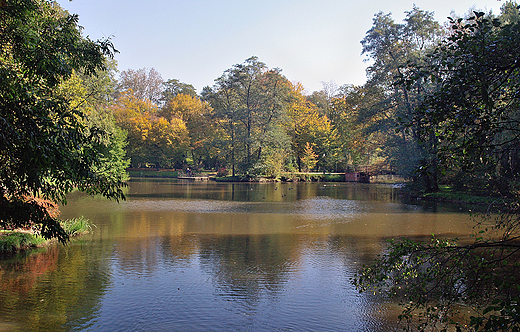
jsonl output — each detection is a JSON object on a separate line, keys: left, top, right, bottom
{"left": 0, "top": 179, "right": 471, "bottom": 331}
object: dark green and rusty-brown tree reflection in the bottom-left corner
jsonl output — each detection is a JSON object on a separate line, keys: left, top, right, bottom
{"left": 0, "top": 243, "right": 110, "bottom": 331}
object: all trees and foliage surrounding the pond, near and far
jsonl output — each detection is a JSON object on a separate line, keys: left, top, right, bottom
{"left": 0, "top": 0, "right": 520, "bottom": 331}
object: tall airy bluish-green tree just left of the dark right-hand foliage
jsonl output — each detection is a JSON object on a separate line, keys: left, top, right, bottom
{"left": 359, "top": 6, "right": 443, "bottom": 187}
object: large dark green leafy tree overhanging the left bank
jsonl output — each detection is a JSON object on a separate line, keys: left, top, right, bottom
{"left": 0, "top": 0, "right": 124, "bottom": 241}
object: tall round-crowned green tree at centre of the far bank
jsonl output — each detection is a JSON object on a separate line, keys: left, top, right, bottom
{"left": 203, "top": 57, "right": 290, "bottom": 174}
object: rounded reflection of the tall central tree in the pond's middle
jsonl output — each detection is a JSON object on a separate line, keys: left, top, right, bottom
{"left": 200, "top": 235, "right": 298, "bottom": 304}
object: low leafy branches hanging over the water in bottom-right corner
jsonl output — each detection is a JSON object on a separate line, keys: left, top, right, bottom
{"left": 353, "top": 230, "right": 520, "bottom": 331}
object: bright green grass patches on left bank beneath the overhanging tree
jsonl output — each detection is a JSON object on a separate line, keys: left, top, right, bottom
{"left": 0, "top": 217, "right": 92, "bottom": 253}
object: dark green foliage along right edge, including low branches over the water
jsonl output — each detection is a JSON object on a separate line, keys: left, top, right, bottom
{"left": 354, "top": 3, "right": 520, "bottom": 331}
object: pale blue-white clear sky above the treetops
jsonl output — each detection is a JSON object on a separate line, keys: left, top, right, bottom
{"left": 57, "top": 0, "right": 505, "bottom": 93}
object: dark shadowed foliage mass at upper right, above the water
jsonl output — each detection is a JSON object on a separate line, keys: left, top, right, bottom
{"left": 408, "top": 6, "right": 520, "bottom": 195}
